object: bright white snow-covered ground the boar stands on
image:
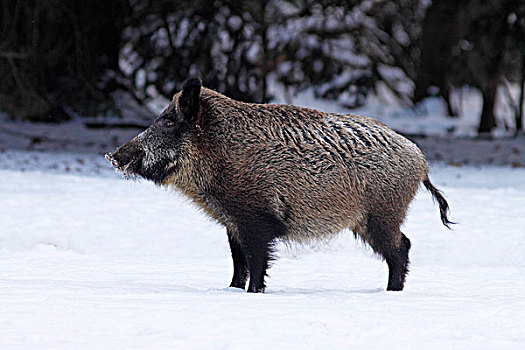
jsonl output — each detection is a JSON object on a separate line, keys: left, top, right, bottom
{"left": 0, "top": 152, "right": 525, "bottom": 350}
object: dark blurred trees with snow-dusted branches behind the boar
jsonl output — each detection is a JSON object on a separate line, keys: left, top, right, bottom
{"left": 0, "top": 0, "right": 525, "bottom": 134}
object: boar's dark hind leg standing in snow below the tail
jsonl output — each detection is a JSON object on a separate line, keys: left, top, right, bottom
{"left": 366, "top": 215, "right": 410, "bottom": 291}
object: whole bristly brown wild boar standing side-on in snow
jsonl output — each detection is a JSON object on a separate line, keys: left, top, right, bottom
{"left": 108, "top": 79, "right": 451, "bottom": 292}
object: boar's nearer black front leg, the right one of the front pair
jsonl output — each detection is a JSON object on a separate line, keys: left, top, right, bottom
{"left": 238, "top": 213, "right": 286, "bottom": 293}
